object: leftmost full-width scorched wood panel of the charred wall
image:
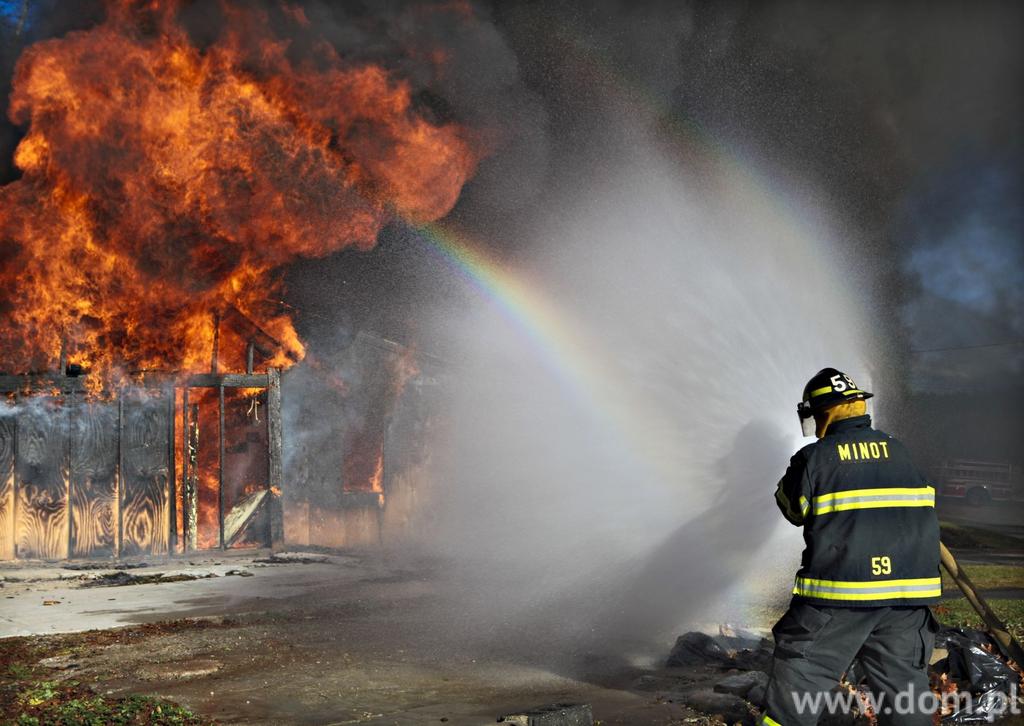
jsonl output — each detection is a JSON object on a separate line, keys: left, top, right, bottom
{"left": 14, "top": 396, "right": 68, "bottom": 560}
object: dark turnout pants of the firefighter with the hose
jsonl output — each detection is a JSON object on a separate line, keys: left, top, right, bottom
{"left": 760, "top": 598, "right": 938, "bottom": 726}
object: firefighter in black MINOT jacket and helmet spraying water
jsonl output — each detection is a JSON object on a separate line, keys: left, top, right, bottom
{"left": 761, "top": 368, "right": 942, "bottom": 726}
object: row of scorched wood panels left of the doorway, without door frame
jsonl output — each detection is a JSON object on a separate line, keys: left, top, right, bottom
{"left": 0, "top": 393, "right": 171, "bottom": 560}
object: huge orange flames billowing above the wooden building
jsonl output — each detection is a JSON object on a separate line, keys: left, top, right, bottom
{"left": 0, "top": 0, "right": 477, "bottom": 384}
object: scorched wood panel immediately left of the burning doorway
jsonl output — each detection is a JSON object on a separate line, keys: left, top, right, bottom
{"left": 121, "top": 396, "right": 170, "bottom": 556}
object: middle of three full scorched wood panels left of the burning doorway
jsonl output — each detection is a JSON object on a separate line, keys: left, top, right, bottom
{"left": 71, "top": 402, "right": 118, "bottom": 557}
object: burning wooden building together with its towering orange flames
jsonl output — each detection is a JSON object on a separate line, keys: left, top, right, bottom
{"left": 0, "top": 0, "right": 477, "bottom": 559}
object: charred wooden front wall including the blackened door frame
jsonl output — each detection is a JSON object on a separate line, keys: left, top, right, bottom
{"left": 0, "top": 371, "right": 282, "bottom": 560}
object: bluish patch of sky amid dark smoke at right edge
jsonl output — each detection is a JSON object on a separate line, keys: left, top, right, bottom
{"left": 901, "top": 154, "right": 1024, "bottom": 392}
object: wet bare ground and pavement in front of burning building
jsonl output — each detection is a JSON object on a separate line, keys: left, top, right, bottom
{"left": 0, "top": 558, "right": 737, "bottom": 726}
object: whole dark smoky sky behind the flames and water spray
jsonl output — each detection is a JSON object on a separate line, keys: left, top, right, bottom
{"left": 0, "top": 0, "right": 1024, "bottom": 399}
